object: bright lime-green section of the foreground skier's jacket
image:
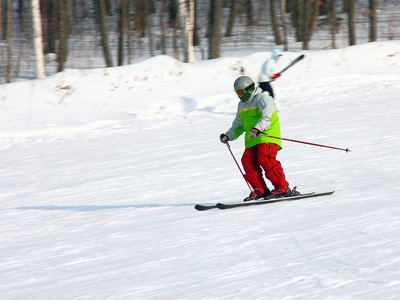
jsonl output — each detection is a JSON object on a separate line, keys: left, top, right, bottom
{"left": 233, "top": 106, "right": 282, "bottom": 150}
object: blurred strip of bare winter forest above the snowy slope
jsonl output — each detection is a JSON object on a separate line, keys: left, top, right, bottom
{"left": 0, "top": 0, "right": 400, "bottom": 84}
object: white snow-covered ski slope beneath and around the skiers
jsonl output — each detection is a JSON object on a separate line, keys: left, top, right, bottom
{"left": 0, "top": 41, "right": 400, "bottom": 300}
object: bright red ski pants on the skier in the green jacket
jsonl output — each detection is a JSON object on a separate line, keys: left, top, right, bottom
{"left": 242, "top": 143, "right": 289, "bottom": 189}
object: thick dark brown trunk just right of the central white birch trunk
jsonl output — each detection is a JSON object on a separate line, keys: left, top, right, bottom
{"left": 208, "top": 0, "right": 222, "bottom": 59}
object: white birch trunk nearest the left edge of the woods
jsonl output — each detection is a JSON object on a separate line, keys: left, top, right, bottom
{"left": 31, "top": 0, "right": 45, "bottom": 78}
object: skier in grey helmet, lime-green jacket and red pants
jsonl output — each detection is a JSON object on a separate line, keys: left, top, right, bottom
{"left": 220, "top": 76, "right": 291, "bottom": 201}
